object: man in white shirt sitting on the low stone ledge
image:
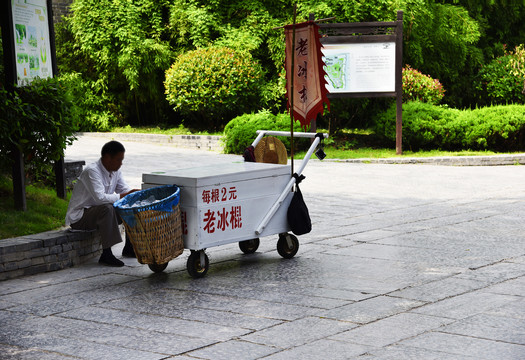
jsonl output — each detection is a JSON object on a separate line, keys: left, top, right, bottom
{"left": 66, "top": 141, "right": 138, "bottom": 266}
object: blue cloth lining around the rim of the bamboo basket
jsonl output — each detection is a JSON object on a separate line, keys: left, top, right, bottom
{"left": 113, "top": 185, "right": 180, "bottom": 227}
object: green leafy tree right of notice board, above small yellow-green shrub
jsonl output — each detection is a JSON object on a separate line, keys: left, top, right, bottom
{"left": 403, "top": 0, "right": 482, "bottom": 107}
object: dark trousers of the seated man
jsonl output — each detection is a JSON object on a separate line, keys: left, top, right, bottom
{"left": 71, "top": 204, "right": 122, "bottom": 249}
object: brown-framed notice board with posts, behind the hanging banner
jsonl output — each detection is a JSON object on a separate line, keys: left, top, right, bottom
{"left": 311, "top": 11, "right": 403, "bottom": 155}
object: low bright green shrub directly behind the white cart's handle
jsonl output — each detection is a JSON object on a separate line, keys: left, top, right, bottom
{"left": 223, "top": 110, "right": 309, "bottom": 154}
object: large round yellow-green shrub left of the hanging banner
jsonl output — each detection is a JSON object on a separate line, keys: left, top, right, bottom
{"left": 164, "top": 47, "right": 264, "bottom": 129}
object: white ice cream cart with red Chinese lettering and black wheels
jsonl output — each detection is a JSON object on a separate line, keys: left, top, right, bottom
{"left": 142, "top": 130, "right": 327, "bottom": 277}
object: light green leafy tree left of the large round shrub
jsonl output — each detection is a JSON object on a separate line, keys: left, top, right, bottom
{"left": 63, "top": 0, "right": 173, "bottom": 121}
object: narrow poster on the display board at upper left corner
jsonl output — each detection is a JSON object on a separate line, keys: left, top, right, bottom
{"left": 11, "top": 0, "right": 53, "bottom": 86}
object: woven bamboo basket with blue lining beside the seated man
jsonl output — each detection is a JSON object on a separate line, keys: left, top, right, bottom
{"left": 114, "top": 185, "right": 184, "bottom": 264}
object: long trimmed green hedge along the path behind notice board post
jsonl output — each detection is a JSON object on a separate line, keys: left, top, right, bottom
{"left": 375, "top": 101, "right": 525, "bottom": 151}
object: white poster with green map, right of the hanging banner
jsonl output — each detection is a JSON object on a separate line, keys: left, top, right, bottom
{"left": 322, "top": 42, "right": 396, "bottom": 93}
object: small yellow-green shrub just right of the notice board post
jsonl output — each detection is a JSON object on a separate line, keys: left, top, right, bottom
{"left": 403, "top": 65, "right": 445, "bottom": 104}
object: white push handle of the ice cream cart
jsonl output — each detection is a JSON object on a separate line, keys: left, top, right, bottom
{"left": 254, "top": 130, "right": 328, "bottom": 236}
